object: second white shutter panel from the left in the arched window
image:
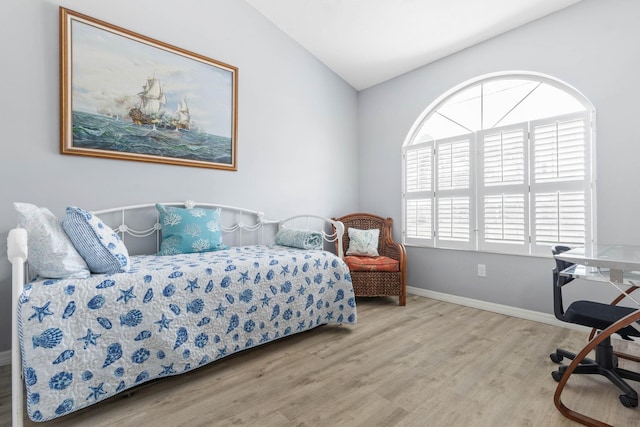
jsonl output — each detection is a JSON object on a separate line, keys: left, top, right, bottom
{"left": 435, "top": 134, "right": 475, "bottom": 249}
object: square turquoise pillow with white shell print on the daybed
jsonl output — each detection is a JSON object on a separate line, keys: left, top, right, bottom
{"left": 156, "top": 204, "right": 228, "bottom": 255}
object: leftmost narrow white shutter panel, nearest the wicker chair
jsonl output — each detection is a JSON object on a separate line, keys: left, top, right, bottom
{"left": 404, "top": 143, "right": 434, "bottom": 246}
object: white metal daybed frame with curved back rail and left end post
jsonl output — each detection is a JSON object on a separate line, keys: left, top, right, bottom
{"left": 7, "top": 200, "right": 344, "bottom": 427}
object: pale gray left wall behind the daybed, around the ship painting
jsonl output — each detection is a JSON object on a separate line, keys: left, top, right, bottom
{"left": 0, "top": 0, "right": 358, "bottom": 351}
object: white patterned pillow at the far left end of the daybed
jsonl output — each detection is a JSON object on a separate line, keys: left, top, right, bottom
{"left": 13, "top": 203, "right": 90, "bottom": 279}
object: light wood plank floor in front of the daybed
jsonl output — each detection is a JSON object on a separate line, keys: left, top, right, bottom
{"left": 0, "top": 296, "right": 640, "bottom": 427}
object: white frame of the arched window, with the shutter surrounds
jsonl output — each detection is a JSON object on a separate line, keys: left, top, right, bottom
{"left": 402, "top": 72, "right": 596, "bottom": 256}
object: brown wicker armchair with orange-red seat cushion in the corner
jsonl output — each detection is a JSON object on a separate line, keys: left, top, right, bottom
{"left": 333, "top": 213, "right": 407, "bottom": 305}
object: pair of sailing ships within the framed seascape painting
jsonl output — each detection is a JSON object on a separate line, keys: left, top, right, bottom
{"left": 129, "top": 74, "right": 191, "bottom": 130}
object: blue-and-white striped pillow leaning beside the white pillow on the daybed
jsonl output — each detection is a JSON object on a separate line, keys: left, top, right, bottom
{"left": 62, "top": 206, "right": 129, "bottom": 273}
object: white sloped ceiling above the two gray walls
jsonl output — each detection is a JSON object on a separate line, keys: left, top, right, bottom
{"left": 245, "top": 0, "right": 581, "bottom": 90}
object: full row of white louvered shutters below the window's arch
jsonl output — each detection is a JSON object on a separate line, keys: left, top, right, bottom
{"left": 404, "top": 112, "right": 593, "bottom": 256}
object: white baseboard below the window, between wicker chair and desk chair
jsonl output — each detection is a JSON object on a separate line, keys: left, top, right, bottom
{"left": 407, "top": 286, "right": 590, "bottom": 331}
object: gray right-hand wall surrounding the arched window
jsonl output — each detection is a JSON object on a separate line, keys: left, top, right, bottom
{"left": 358, "top": 0, "right": 640, "bottom": 313}
